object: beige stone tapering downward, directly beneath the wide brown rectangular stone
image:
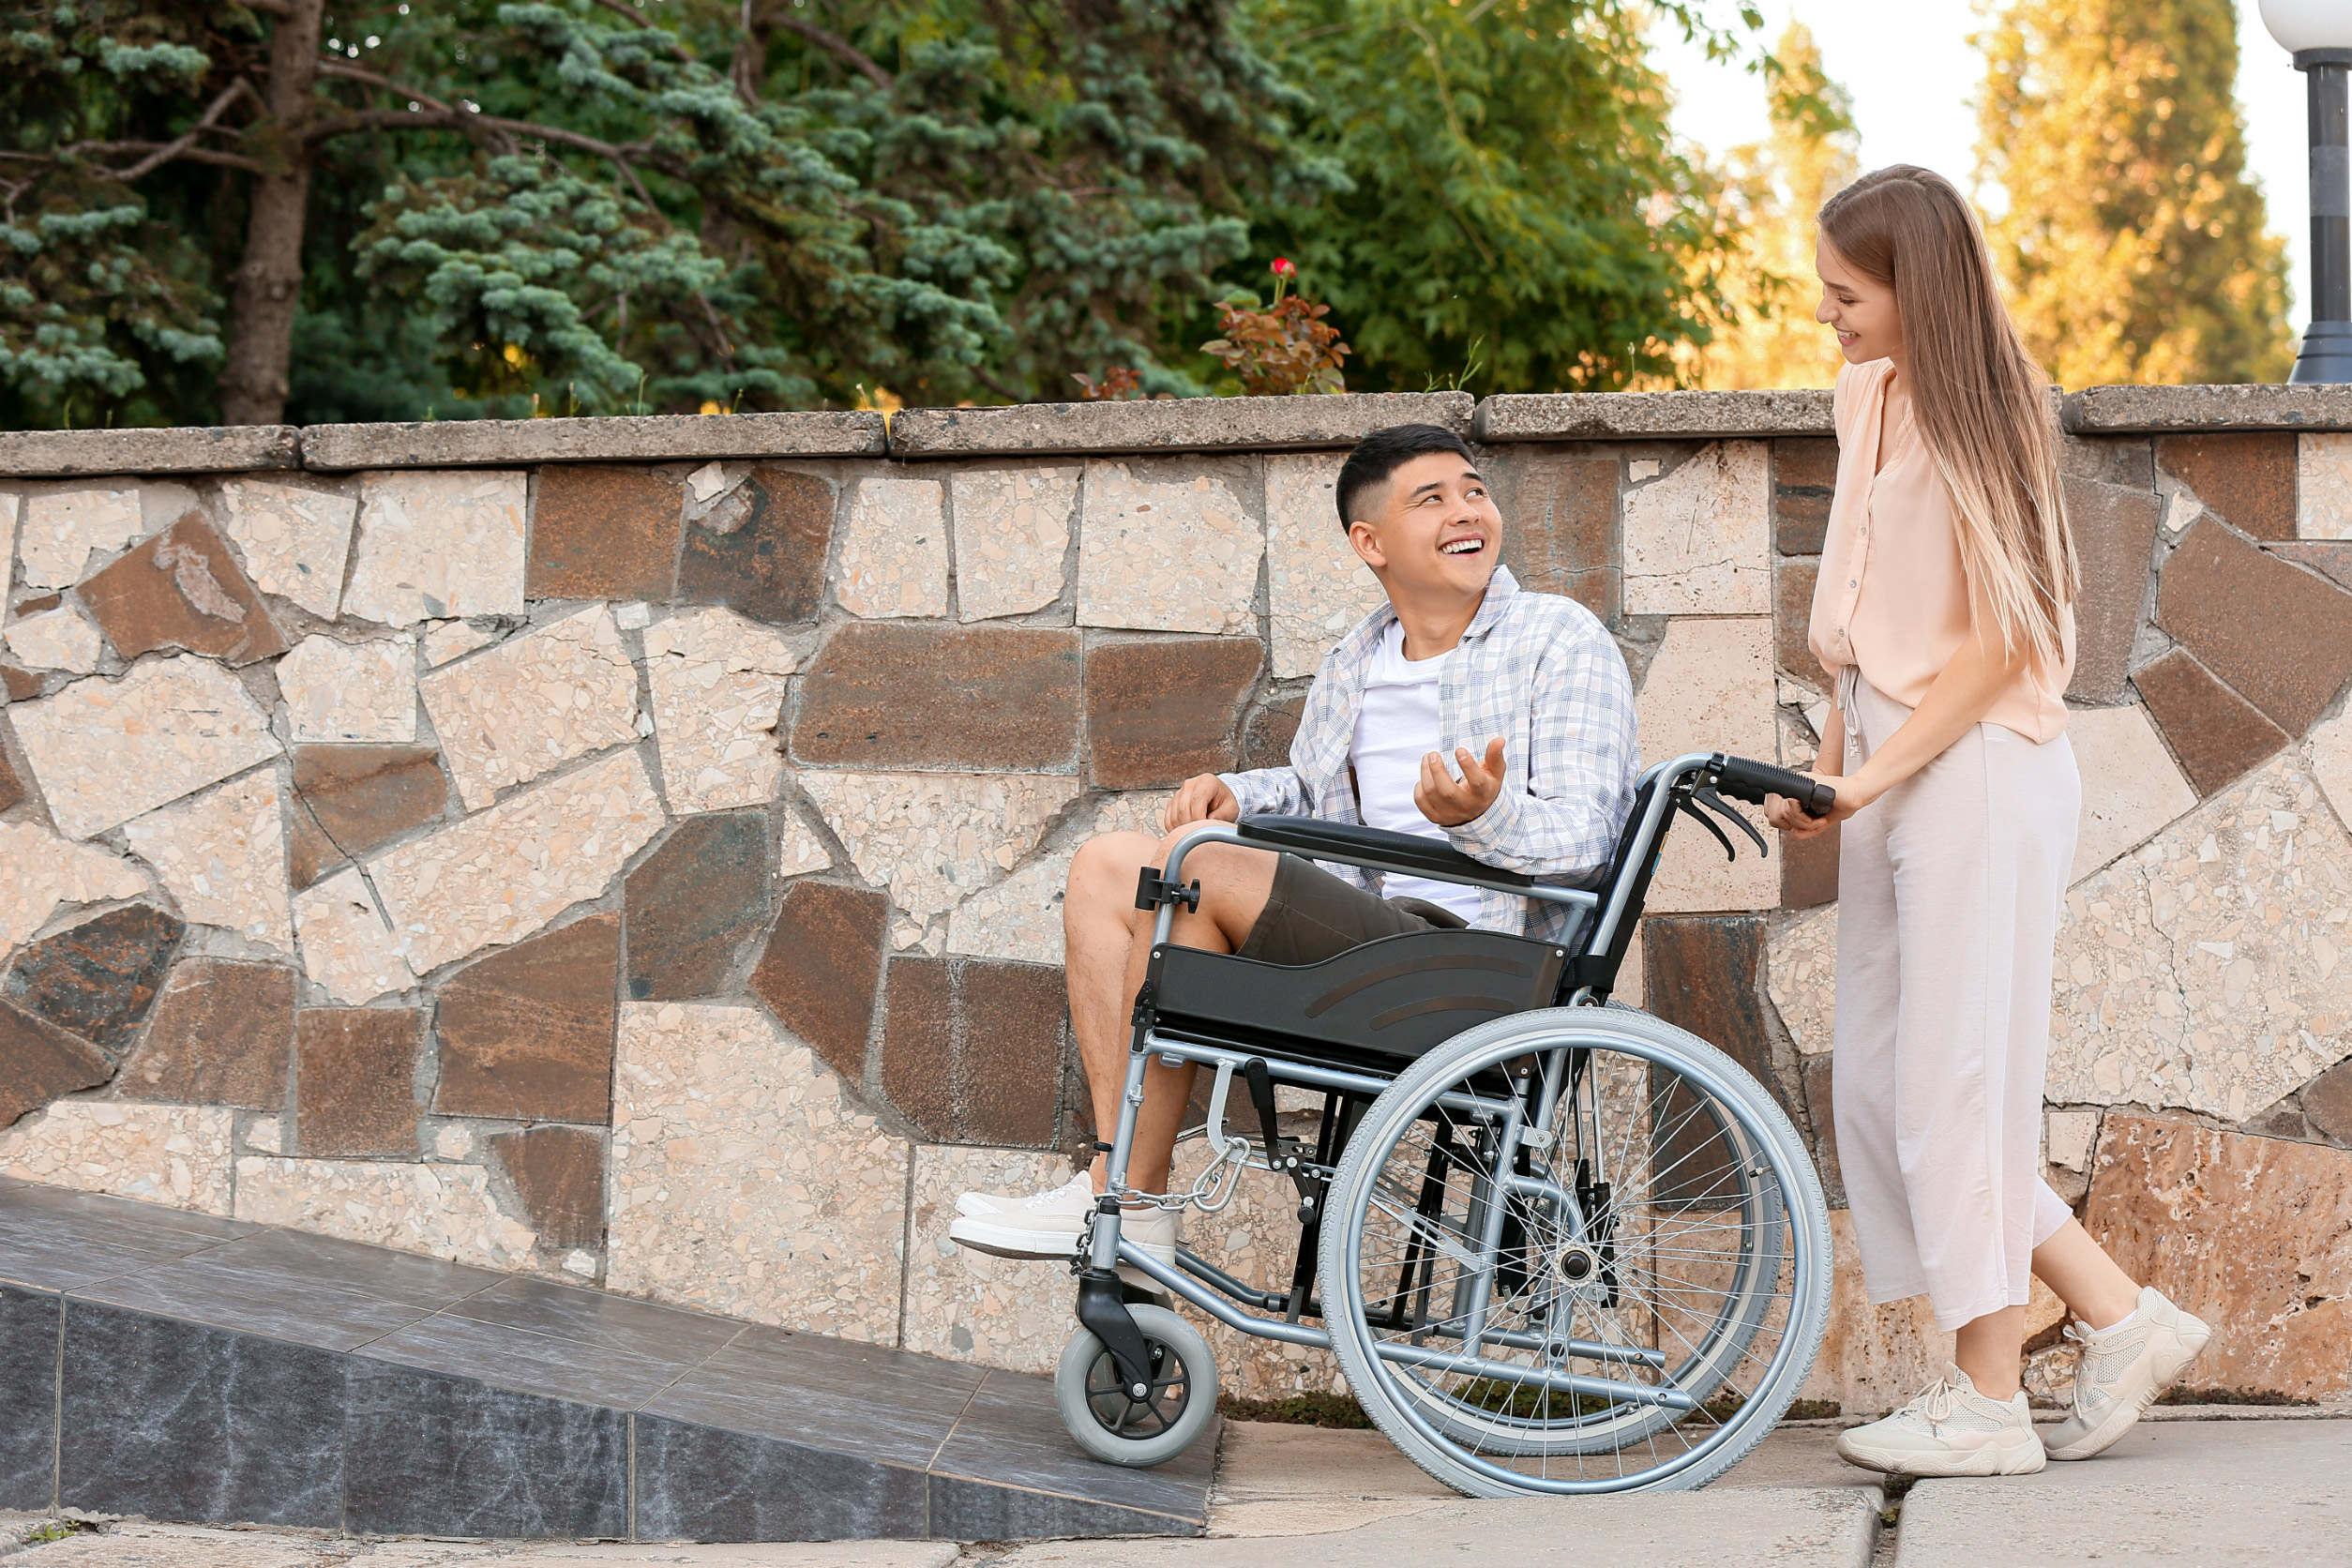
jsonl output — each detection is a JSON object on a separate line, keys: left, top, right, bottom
{"left": 800, "top": 771, "right": 1079, "bottom": 924}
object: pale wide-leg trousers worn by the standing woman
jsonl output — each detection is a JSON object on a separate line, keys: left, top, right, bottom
{"left": 1832, "top": 670, "right": 2082, "bottom": 1333}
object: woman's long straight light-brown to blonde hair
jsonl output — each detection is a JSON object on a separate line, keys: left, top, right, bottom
{"left": 1820, "top": 164, "right": 2082, "bottom": 670}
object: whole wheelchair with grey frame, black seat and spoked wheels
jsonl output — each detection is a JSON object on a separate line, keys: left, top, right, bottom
{"left": 1054, "top": 752, "right": 1834, "bottom": 1498}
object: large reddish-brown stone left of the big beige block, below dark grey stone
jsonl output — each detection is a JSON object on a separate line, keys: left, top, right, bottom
{"left": 432, "top": 914, "right": 621, "bottom": 1122}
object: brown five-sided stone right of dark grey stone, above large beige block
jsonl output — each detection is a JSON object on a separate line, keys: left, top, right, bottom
{"left": 750, "top": 880, "right": 889, "bottom": 1084}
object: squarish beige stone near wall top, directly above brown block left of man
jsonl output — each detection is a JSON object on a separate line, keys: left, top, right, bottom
{"left": 1078, "top": 459, "right": 1265, "bottom": 632}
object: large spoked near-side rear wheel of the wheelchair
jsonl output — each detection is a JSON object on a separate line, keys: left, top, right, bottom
{"left": 1321, "top": 1006, "right": 1830, "bottom": 1498}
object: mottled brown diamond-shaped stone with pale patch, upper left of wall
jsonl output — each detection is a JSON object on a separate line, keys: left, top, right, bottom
{"left": 78, "top": 512, "right": 287, "bottom": 665}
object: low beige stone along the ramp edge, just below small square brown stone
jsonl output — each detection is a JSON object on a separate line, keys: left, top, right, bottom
{"left": 237, "top": 1154, "right": 538, "bottom": 1272}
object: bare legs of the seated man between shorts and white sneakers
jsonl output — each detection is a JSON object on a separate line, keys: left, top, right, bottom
{"left": 1061, "top": 827, "right": 1274, "bottom": 1192}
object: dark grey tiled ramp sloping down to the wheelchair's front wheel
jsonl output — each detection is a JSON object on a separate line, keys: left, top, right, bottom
{"left": 0, "top": 1180, "right": 1216, "bottom": 1540}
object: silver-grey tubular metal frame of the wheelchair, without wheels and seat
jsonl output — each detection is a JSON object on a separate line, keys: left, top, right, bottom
{"left": 1073, "top": 752, "right": 1787, "bottom": 1490}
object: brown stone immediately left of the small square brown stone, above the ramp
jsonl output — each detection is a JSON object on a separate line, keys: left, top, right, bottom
{"left": 120, "top": 959, "right": 294, "bottom": 1109}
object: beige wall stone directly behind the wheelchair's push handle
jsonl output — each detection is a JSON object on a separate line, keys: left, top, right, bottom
{"left": 1635, "top": 611, "right": 1781, "bottom": 914}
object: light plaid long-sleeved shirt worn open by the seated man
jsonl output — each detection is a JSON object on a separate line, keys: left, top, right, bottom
{"left": 1221, "top": 566, "right": 1639, "bottom": 941}
